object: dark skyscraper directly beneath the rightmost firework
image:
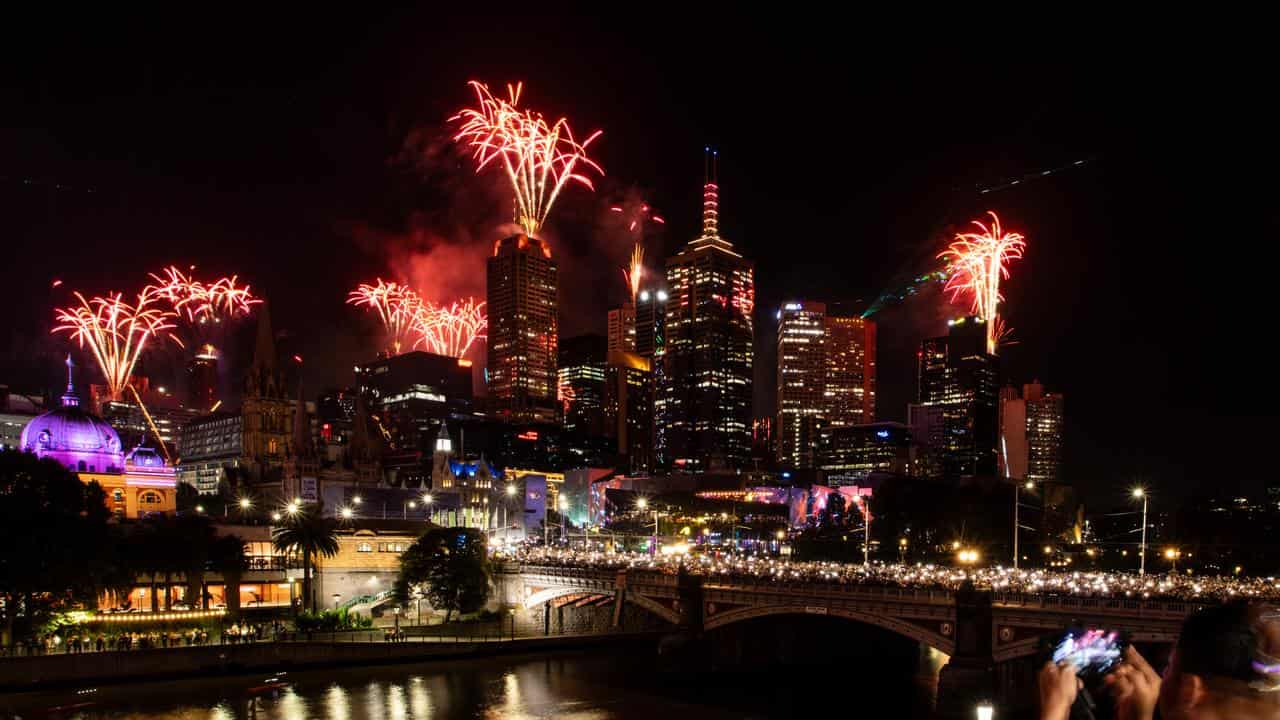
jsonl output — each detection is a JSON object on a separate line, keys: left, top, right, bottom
{"left": 913, "top": 318, "right": 1000, "bottom": 478}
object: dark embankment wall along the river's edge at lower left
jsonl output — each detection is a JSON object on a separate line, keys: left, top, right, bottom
{"left": 0, "top": 633, "right": 659, "bottom": 692}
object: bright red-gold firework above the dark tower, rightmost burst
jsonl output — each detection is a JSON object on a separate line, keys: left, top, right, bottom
{"left": 938, "top": 210, "right": 1027, "bottom": 354}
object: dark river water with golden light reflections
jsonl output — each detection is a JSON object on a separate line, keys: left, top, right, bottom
{"left": 0, "top": 646, "right": 932, "bottom": 720}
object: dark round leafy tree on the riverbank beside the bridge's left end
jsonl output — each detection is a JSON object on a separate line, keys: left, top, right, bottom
{"left": 394, "top": 528, "right": 490, "bottom": 623}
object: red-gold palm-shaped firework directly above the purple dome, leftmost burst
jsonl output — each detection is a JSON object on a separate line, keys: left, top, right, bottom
{"left": 52, "top": 290, "right": 178, "bottom": 400}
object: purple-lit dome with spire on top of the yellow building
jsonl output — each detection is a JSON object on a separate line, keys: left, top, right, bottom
{"left": 19, "top": 356, "right": 124, "bottom": 473}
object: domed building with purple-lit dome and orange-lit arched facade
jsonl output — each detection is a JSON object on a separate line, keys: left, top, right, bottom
{"left": 18, "top": 355, "right": 177, "bottom": 518}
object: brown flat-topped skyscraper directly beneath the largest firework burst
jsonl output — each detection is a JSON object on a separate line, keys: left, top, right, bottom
{"left": 486, "top": 234, "right": 558, "bottom": 421}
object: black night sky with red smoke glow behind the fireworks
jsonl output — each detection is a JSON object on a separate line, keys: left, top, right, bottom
{"left": 0, "top": 6, "right": 1280, "bottom": 507}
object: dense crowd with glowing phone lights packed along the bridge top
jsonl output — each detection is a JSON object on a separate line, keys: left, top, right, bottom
{"left": 506, "top": 547, "right": 1280, "bottom": 601}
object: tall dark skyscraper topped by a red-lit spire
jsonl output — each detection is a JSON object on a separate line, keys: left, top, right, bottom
{"left": 657, "top": 155, "right": 755, "bottom": 470}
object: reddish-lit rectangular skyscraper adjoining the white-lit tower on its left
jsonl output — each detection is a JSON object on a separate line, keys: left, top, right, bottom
{"left": 823, "top": 315, "right": 876, "bottom": 427}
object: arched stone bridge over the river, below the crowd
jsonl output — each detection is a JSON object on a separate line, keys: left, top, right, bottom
{"left": 500, "top": 565, "right": 1202, "bottom": 712}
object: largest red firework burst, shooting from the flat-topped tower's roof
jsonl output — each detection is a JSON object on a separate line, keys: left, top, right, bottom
{"left": 449, "top": 81, "right": 604, "bottom": 237}
